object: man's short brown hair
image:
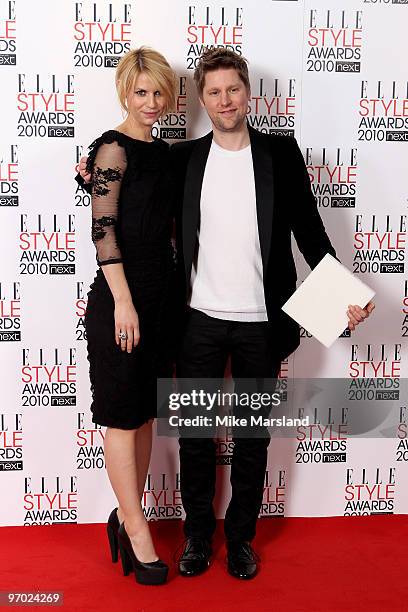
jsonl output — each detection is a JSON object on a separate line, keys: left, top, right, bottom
{"left": 194, "top": 47, "right": 251, "bottom": 97}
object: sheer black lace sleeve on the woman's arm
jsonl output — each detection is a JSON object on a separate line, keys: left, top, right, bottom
{"left": 88, "top": 142, "right": 127, "bottom": 266}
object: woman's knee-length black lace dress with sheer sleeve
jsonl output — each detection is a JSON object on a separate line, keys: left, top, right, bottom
{"left": 85, "top": 130, "right": 174, "bottom": 429}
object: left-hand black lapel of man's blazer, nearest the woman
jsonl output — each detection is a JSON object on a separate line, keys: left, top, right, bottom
{"left": 182, "top": 132, "right": 212, "bottom": 288}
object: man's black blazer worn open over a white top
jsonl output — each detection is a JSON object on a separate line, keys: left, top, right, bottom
{"left": 171, "top": 126, "right": 336, "bottom": 359}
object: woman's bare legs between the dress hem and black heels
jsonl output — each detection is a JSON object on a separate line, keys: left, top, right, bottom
{"left": 104, "top": 427, "right": 158, "bottom": 563}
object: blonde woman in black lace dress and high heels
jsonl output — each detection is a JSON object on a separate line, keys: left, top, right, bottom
{"left": 81, "top": 47, "right": 176, "bottom": 584}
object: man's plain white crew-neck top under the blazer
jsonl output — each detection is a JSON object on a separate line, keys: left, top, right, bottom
{"left": 190, "top": 140, "right": 268, "bottom": 321}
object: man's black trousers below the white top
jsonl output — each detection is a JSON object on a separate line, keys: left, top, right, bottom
{"left": 177, "top": 309, "right": 280, "bottom": 542}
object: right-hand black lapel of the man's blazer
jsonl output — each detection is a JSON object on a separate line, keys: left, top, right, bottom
{"left": 248, "top": 125, "right": 274, "bottom": 278}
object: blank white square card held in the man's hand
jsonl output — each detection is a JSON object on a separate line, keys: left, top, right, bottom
{"left": 282, "top": 253, "right": 375, "bottom": 348}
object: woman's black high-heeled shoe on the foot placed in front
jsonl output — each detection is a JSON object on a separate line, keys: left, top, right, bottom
{"left": 118, "top": 523, "right": 169, "bottom": 585}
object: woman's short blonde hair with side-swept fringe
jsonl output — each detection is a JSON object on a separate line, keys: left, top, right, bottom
{"left": 116, "top": 46, "right": 177, "bottom": 114}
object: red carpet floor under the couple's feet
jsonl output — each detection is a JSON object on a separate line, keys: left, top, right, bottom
{"left": 0, "top": 515, "right": 408, "bottom": 612}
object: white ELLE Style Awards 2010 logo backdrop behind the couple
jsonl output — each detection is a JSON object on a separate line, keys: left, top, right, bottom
{"left": 0, "top": 0, "right": 408, "bottom": 525}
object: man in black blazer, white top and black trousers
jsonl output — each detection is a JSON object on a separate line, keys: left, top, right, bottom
{"left": 81, "top": 49, "right": 374, "bottom": 579}
